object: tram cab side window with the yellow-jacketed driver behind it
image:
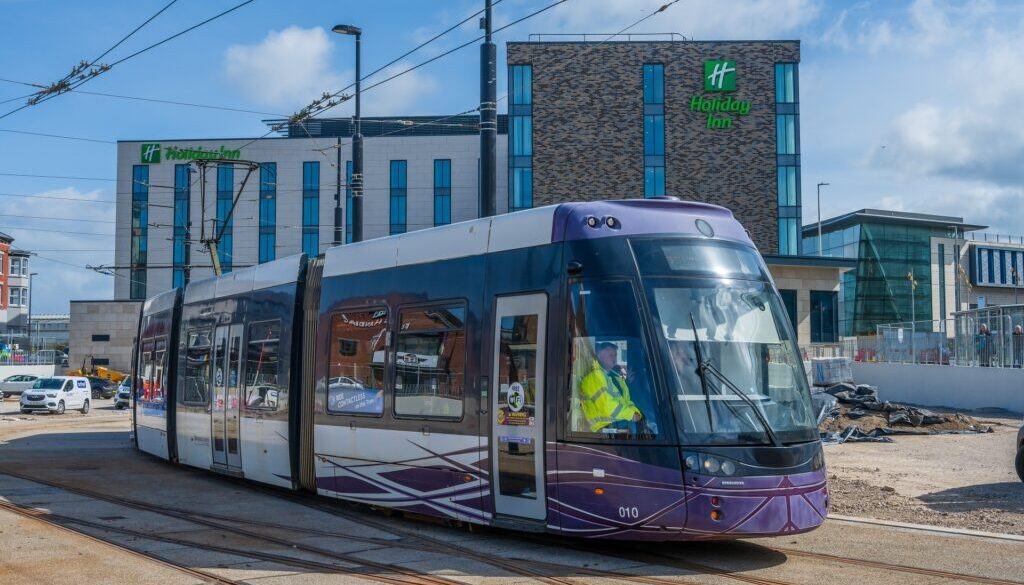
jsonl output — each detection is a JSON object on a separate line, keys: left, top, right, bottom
{"left": 568, "top": 281, "right": 658, "bottom": 440}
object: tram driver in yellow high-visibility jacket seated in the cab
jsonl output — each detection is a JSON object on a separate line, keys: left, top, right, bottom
{"left": 579, "top": 341, "right": 650, "bottom": 434}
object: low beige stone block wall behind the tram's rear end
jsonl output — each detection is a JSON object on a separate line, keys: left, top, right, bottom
{"left": 68, "top": 300, "right": 142, "bottom": 372}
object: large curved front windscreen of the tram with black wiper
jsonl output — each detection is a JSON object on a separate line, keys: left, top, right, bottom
{"left": 646, "top": 278, "right": 818, "bottom": 445}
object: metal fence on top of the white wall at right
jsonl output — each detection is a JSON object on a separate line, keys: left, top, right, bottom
{"left": 831, "top": 305, "right": 1024, "bottom": 368}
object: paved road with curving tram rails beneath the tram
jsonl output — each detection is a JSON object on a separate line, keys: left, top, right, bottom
{"left": 0, "top": 411, "right": 1024, "bottom": 585}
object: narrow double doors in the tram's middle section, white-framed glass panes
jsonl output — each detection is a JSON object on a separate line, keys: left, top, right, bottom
{"left": 210, "top": 324, "right": 242, "bottom": 471}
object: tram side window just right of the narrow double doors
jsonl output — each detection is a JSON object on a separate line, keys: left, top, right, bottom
{"left": 246, "top": 321, "right": 288, "bottom": 411}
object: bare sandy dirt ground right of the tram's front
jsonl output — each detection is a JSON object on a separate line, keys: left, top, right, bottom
{"left": 825, "top": 414, "right": 1024, "bottom": 535}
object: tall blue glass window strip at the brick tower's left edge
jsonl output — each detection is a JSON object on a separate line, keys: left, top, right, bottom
{"left": 508, "top": 65, "right": 534, "bottom": 211}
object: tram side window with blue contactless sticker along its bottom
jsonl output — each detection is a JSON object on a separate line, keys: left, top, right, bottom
{"left": 327, "top": 308, "right": 387, "bottom": 415}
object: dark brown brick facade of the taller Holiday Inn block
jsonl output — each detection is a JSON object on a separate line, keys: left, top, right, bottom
{"left": 508, "top": 41, "right": 800, "bottom": 254}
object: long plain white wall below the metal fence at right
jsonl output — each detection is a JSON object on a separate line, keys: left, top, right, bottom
{"left": 853, "top": 362, "right": 1024, "bottom": 413}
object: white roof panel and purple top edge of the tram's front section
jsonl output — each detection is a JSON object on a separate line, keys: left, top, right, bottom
{"left": 324, "top": 198, "right": 753, "bottom": 278}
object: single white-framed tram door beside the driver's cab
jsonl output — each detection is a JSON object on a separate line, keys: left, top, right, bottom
{"left": 490, "top": 294, "right": 548, "bottom": 520}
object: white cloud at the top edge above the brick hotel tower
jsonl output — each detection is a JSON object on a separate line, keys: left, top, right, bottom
{"left": 525, "top": 0, "right": 821, "bottom": 40}
